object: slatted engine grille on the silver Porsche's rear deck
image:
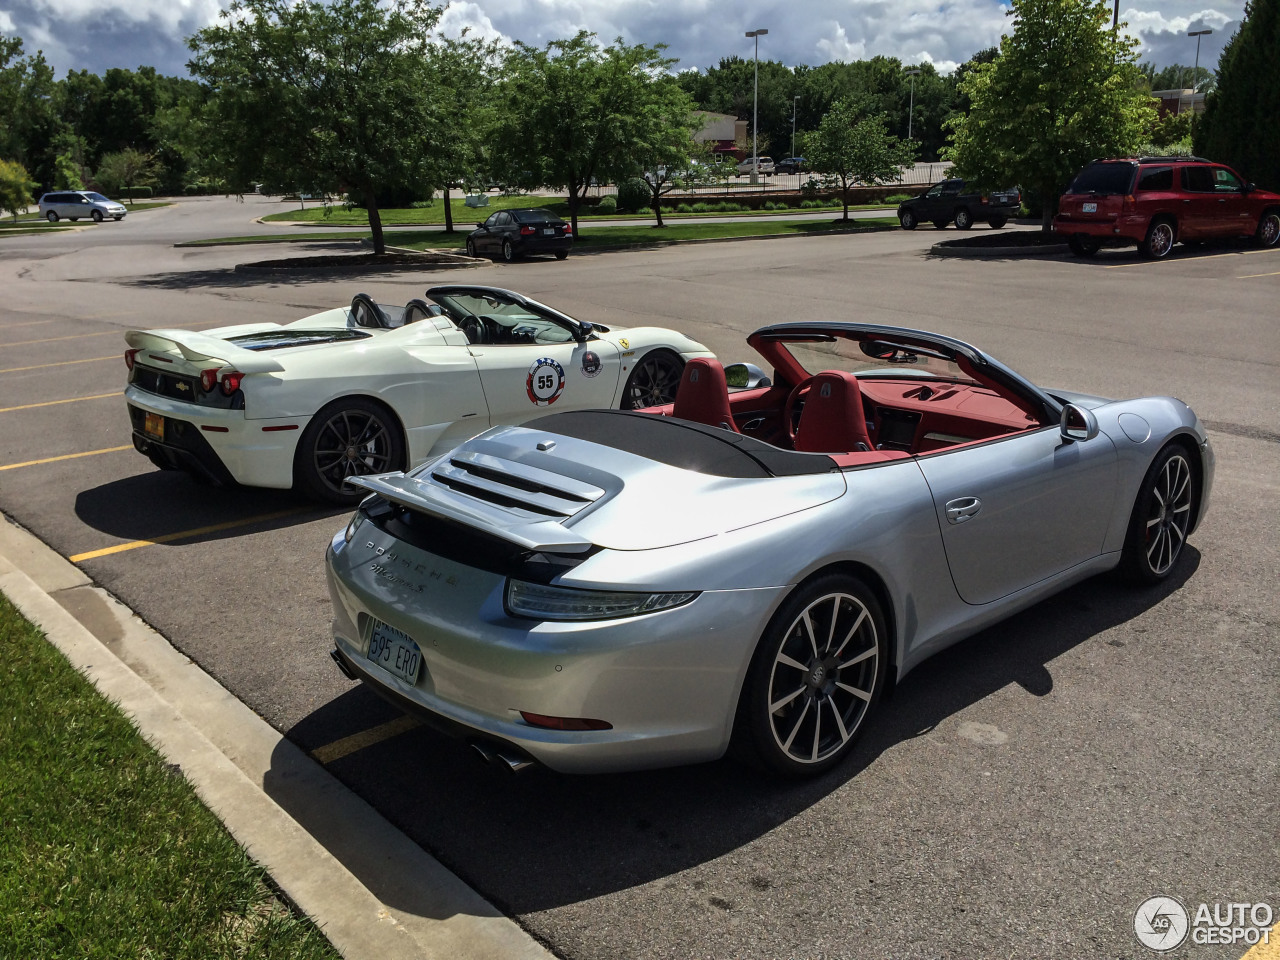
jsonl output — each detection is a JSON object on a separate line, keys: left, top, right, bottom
{"left": 431, "top": 453, "right": 604, "bottom": 518}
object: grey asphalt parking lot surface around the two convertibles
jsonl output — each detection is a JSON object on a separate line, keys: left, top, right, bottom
{"left": 0, "top": 198, "right": 1280, "bottom": 960}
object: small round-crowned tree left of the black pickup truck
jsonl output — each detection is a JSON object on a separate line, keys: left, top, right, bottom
{"left": 804, "top": 97, "right": 915, "bottom": 220}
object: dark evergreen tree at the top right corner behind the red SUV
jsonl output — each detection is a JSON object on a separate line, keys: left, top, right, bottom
{"left": 1193, "top": 0, "right": 1280, "bottom": 189}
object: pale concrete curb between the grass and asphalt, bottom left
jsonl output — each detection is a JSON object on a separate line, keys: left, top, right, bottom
{"left": 0, "top": 515, "right": 552, "bottom": 960}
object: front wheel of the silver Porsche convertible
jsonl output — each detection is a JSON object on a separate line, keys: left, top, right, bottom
{"left": 1120, "top": 443, "right": 1197, "bottom": 584}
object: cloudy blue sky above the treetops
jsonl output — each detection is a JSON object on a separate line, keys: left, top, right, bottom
{"left": 0, "top": 0, "right": 1244, "bottom": 77}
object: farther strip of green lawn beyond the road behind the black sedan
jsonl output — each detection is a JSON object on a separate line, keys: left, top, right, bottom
{"left": 262, "top": 196, "right": 888, "bottom": 229}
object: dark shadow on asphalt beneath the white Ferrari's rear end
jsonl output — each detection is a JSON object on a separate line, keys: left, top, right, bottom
{"left": 76, "top": 470, "right": 351, "bottom": 543}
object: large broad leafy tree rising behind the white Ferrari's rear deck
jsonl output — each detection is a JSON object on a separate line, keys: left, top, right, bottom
{"left": 188, "top": 0, "right": 445, "bottom": 253}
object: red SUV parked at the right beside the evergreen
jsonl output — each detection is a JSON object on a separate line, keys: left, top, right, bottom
{"left": 1053, "top": 156, "right": 1280, "bottom": 260}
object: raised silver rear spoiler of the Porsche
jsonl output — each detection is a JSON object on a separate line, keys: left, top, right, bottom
{"left": 347, "top": 474, "right": 595, "bottom": 553}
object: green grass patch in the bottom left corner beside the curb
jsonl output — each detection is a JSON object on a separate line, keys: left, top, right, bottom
{"left": 0, "top": 596, "right": 338, "bottom": 960}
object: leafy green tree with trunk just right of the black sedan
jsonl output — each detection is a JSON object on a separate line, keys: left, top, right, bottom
{"left": 494, "top": 31, "right": 687, "bottom": 234}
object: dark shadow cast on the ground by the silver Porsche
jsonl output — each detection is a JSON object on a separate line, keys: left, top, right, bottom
{"left": 265, "top": 545, "right": 1199, "bottom": 915}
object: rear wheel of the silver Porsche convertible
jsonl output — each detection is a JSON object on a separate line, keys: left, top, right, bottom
{"left": 739, "top": 573, "right": 888, "bottom": 776}
